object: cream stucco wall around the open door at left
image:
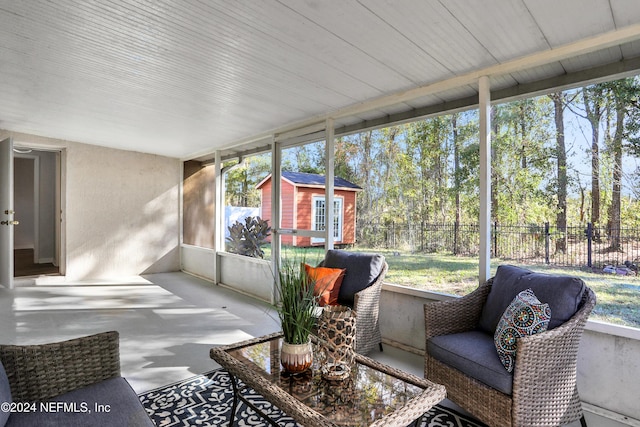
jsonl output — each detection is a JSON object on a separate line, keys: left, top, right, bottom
{"left": 0, "top": 131, "right": 182, "bottom": 280}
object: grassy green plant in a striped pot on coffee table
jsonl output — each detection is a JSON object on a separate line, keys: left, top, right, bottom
{"left": 275, "top": 260, "right": 318, "bottom": 373}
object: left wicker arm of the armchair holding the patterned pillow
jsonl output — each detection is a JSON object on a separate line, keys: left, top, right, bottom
{"left": 424, "top": 279, "right": 493, "bottom": 340}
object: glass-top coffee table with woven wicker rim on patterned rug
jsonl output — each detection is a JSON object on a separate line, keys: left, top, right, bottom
{"left": 211, "top": 333, "right": 446, "bottom": 427}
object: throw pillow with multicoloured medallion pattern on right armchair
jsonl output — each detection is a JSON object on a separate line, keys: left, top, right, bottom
{"left": 493, "top": 289, "right": 551, "bottom": 372}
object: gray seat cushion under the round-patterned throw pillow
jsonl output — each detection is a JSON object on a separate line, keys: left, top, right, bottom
{"left": 427, "top": 331, "right": 513, "bottom": 395}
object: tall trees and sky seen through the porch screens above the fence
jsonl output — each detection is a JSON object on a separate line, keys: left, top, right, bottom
{"left": 226, "top": 77, "right": 640, "bottom": 242}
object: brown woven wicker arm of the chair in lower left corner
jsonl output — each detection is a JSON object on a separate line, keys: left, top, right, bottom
{"left": 0, "top": 331, "right": 120, "bottom": 402}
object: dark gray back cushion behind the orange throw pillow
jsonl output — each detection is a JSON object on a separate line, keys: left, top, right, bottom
{"left": 322, "top": 249, "right": 384, "bottom": 307}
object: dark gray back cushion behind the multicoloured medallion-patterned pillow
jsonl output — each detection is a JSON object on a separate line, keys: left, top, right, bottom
{"left": 479, "top": 265, "right": 585, "bottom": 334}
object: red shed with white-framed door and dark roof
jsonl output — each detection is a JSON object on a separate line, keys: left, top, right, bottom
{"left": 256, "top": 172, "right": 362, "bottom": 246}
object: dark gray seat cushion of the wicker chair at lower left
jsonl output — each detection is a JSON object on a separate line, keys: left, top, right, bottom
{"left": 6, "top": 377, "right": 155, "bottom": 427}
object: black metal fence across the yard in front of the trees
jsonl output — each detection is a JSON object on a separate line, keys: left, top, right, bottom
{"left": 357, "top": 222, "right": 640, "bottom": 268}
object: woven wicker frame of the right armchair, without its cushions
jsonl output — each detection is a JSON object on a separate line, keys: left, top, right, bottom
{"left": 424, "top": 270, "right": 596, "bottom": 427}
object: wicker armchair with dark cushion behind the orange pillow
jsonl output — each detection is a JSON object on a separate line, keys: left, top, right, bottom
{"left": 320, "top": 249, "right": 389, "bottom": 354}
